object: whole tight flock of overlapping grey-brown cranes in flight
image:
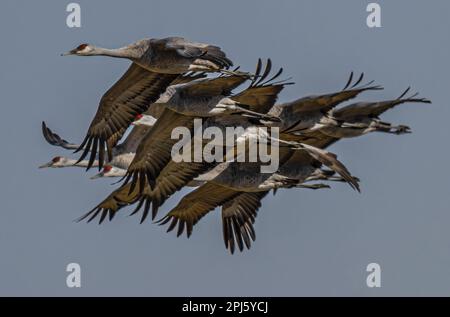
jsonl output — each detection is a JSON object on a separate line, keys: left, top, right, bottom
{"left": 41, "top": 37, "right": 430, "bottom": 253}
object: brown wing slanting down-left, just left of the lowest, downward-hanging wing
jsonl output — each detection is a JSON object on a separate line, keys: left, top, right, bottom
{"left": 158, "top": 182, "right": 239, "bottom": 237}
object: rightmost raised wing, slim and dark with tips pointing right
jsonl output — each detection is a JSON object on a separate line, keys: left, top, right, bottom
{"left": 333, "top": 88, "right": 431, "bottom": 121}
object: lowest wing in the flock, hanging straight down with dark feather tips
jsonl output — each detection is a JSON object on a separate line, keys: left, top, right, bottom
{"left": 222, "top": 191, "right": 269, "bottom": 254}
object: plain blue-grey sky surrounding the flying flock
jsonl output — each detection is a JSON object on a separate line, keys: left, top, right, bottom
{"left": 0, "top": 0, "right": 450, "bottom": 296}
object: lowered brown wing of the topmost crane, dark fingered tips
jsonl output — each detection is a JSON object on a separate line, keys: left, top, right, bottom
{"left": 77, "top": 63, "right": 178, "bottom": 169}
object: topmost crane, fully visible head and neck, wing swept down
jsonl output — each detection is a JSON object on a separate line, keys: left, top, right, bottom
{"left": 63, "top": 37, "right": 236, "bottom": 169}
